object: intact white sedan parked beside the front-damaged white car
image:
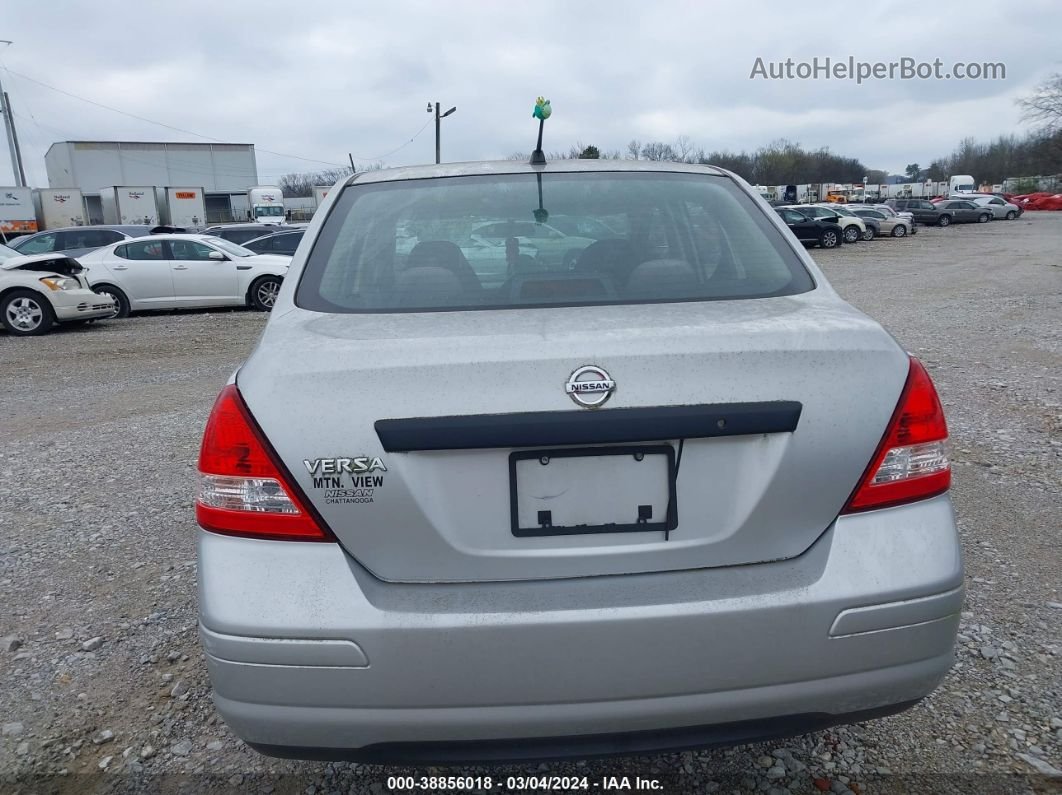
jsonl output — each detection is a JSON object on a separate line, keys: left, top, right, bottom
{"left": 81, "top": 235, "right": 291, "bottom": 317}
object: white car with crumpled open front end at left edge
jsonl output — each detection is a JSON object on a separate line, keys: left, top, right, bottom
{"left": 0, "top": 245, "right": 115, "bottom": 336}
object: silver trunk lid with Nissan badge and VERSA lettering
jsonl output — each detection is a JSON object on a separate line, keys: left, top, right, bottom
{"left": 238, "top": 291, "right": 907, "bottom": 582}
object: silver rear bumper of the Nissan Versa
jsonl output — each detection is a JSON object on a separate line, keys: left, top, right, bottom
{"left": 199, "top": 496, "right": 963, "bottom": 761}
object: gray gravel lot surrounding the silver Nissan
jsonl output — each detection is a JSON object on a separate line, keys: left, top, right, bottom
{"left": 0, "top": 213, "right": 1062, "bottom": 794}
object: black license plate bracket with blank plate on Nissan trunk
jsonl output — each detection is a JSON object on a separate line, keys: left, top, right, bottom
{"left": 509, "top": 445, "right": 678, "bottom": 537}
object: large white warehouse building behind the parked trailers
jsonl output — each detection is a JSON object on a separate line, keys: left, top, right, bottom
{"left": 45, "top": 141, "right": 265, "bottom": 224}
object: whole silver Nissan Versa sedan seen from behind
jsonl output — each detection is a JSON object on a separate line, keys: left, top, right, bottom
{"left": 195, "top": 160, "right": 963, "bottom": 763}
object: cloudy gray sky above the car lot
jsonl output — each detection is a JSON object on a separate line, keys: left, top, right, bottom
{"left": 0, "top": 0, "right": 1062, "bottom": 185}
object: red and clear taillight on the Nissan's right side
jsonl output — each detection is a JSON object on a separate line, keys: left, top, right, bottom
{"left": 841, "top": 357, "right": 952, "bottom": 514}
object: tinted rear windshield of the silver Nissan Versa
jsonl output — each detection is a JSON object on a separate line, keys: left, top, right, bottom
{"left": 295, "top": 172, "right": 815, "bottom": 312}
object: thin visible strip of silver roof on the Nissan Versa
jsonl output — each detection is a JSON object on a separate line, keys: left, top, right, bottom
{"left": 344, "top": 159, "right": 731, "bottom": 185}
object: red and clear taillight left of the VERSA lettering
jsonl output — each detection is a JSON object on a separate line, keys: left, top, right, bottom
{"left": 195, "top": 384, "right": 335, "bottom": 541}
